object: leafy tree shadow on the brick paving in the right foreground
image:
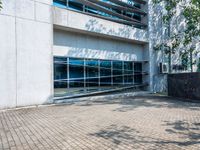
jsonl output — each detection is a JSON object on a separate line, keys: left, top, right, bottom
{"left": 90, "top": 121, "right": 200, "bottom": 148}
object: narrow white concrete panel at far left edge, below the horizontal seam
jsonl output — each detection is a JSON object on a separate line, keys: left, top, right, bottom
{"left": 0, "top": 15, "right": 17, "bottom": 108}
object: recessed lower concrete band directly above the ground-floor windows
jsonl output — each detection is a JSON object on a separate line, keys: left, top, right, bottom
{"left": 54, "top": 30, "right": 147, "bottom": 61}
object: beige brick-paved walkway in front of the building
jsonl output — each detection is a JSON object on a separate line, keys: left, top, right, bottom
{"left": 0, "top": 96, "right": 200, "bottom": 150}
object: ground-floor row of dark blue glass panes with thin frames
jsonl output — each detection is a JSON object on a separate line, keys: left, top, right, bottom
{"left": 54, "top": 57, "right": 146, "bottom": 96}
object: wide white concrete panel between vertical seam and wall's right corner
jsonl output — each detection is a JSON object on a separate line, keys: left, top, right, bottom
{"left": 16, "top": 19, "right": 52, "bottom": 106}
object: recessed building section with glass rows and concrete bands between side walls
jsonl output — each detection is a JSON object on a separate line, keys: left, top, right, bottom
{"left": 53, "top": 0, "right": 149, "bottom": 98}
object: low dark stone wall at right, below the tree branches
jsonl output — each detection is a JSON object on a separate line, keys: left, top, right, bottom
{"left": 168, "top": 73, "right": 200, "bottom": 100}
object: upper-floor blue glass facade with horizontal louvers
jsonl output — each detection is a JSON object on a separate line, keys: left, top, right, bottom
{"left": 54, "top": 0, "right": 147, "bottom": 28}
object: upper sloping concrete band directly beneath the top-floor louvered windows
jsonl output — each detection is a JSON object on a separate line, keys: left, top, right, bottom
{"left": 53, "top": 7, "right": 148, "bottom": 43}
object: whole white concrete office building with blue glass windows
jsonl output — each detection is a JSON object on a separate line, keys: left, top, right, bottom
{"left": 0, "top": 0, "right": 198, "bottom": 108}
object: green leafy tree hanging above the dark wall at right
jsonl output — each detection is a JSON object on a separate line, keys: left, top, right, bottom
{"left": 153, "top": 0, "right": 200, "bottom": 73}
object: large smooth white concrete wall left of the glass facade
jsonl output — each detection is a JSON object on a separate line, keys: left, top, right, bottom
{"left": 0, "top": 0, "right": 53, "bottom": 108}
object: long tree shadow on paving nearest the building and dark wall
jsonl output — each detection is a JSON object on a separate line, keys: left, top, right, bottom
{"left": 77, "top": 95, "right": 200, "bottom": 112}
